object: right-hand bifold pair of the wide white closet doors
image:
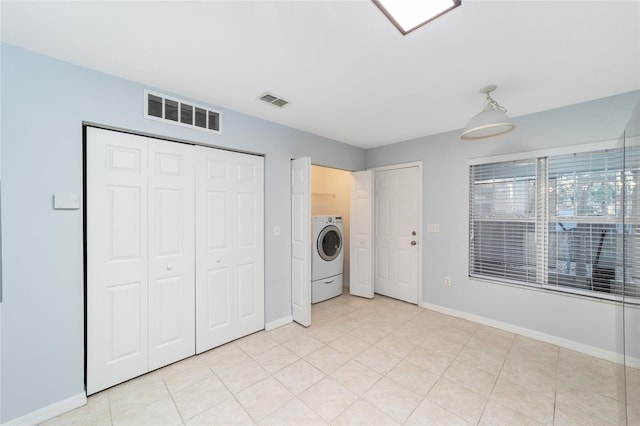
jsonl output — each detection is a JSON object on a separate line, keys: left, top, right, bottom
{"left": 196, "top": 147, "right": 264, "bottom": 353}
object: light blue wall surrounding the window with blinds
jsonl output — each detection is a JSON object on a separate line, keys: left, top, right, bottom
{"left": 366, "top": 91, "right": 640, "bottom": 360}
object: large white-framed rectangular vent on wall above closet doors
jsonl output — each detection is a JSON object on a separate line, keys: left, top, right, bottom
{"left": 144, "top": 90, "right": 220, "bottom": 133}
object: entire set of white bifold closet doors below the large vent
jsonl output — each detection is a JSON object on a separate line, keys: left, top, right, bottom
{"left": 86, "top": 127, "right": 264, "bottom": 394}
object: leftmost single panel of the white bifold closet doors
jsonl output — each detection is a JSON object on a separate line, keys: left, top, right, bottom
{"left": 86, "top": 128, "right": 148, "bottom": 394}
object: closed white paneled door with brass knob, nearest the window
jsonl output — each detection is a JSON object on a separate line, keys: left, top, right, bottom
{"left": 374, "top": 166, "right": 421, "bottom": 303}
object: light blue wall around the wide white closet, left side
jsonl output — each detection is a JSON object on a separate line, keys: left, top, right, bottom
{"left": 0, "top": 44, "right": 364, "bottom": 423}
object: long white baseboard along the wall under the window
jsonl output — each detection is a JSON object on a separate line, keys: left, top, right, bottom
{"left": 419, "top": 302, "right": 640, "bottom": 368}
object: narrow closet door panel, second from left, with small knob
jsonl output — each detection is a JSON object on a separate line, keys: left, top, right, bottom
{"left": 148, "top": 139, "right": 195, "bottom": 370}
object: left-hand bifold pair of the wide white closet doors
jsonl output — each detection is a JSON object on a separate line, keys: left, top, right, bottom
{"left": 86, "top": 128, "right": 195, "bottom": 394}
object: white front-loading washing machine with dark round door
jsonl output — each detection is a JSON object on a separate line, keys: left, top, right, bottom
{"left": 311, "top": 216, "right": 344, "bottom": 303}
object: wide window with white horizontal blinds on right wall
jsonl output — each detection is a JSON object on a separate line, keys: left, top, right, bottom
{"left": 469, "top": 147, "right": 640, "bottom": 300}
